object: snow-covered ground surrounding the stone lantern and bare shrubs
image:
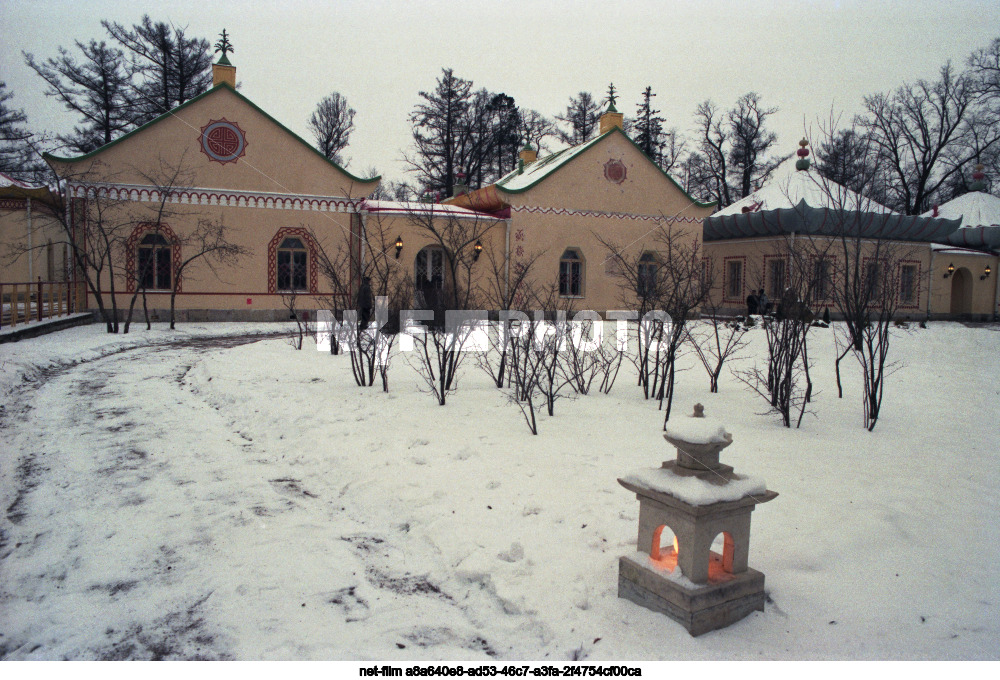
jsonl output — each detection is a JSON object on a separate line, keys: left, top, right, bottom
{"left": 0, "top": 323, "right": 1000, "bottom": 661}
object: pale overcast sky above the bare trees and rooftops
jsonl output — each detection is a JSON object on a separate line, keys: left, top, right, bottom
{"left": 0, "top": 0, "right": 1000, "bottom": 186}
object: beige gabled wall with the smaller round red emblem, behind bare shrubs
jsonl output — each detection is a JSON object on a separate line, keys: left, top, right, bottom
{"left": 501, "top": 129, "right": 713, "bottom": 312}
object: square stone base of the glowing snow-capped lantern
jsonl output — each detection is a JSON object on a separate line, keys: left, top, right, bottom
{"left": 618, "top": 554, "right": 765, "bottom": 636}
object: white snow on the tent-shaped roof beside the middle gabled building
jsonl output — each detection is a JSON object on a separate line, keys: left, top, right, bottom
{"left": 713, "top": 156, "right": 892, "bottom": 217}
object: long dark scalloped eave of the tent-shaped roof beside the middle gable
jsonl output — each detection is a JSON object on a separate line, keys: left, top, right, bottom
{"left": 704, "top": 199, "right": 959, "bottom": 245}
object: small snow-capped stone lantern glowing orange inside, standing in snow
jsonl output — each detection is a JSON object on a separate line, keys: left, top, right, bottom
{"left": 618, "top": 404, "right": 778, "bottom": 635}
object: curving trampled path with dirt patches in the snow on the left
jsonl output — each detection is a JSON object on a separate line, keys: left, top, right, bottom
{"left": 0, "top": 335, "right": 284, "bottom": 659}
